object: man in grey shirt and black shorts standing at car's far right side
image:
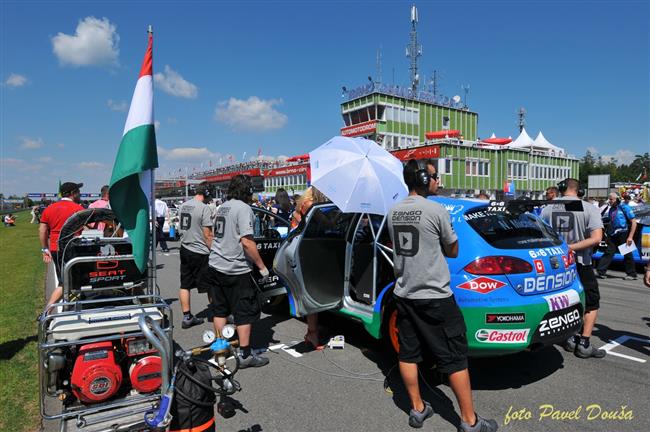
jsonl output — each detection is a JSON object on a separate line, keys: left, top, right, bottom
{"left": 541, "top": 178, "right": 606, "bottom": 358}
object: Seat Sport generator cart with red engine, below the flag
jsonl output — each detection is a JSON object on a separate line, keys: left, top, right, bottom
{"left": 38, "top": 209, "right": 173, "bottom": 432}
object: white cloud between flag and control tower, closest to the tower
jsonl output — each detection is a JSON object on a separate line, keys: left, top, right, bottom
{"left": 215, "top": 96, "right": 288, "bottom": 131}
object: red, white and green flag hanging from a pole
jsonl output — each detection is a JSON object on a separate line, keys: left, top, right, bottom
{"left": 109, "top": 33, "right": 158, "bottom": 272}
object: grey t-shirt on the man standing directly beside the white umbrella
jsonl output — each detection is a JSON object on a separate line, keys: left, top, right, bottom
{"left": 388, "top": 195, "right": 458, "bottom": 299}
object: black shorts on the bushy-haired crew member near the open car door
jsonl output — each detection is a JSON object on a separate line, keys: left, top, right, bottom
{"left": 201, "top": 266, "right": 261, "bottom": 325}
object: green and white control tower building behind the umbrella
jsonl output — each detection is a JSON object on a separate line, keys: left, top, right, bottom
{"left": 341, "top": 89, "right": 579, "bottom": 198}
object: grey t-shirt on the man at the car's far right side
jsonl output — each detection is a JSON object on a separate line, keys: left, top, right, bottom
{"left": 541, "top": 196, "right": 603, "bottom": 265}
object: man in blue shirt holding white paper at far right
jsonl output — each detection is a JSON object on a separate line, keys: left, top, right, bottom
{"left": 596, "top": 193, "right": 637, "bottom": 280}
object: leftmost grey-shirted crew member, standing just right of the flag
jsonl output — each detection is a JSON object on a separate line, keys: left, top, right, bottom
{"left": 178, "top": 186, "right": 212, "bottom": 329}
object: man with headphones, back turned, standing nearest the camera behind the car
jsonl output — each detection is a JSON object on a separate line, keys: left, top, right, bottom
{"left": 388, "top": 159, "right": 498, "bottom": 432}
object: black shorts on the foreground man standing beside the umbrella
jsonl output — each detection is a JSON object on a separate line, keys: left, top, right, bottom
{"left": 395, "top": 295, "right": 467, "bottom": 374}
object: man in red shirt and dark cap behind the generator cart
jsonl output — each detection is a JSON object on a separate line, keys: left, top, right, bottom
{"left": 38, "top": 182, "right": 84, "bottom": 308}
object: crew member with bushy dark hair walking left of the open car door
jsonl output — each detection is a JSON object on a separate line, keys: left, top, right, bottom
{"left": 201, "top": 175, "right": 269, "bottom": 368}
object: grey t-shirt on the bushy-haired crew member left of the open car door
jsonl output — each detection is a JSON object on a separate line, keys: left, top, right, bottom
{"left": 209, "top": 199, "right": 255, "bottom": 275}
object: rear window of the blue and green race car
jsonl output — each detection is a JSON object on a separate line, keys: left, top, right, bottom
{"left": 464, "top": 207, "right": 562, "bottom": 249}
